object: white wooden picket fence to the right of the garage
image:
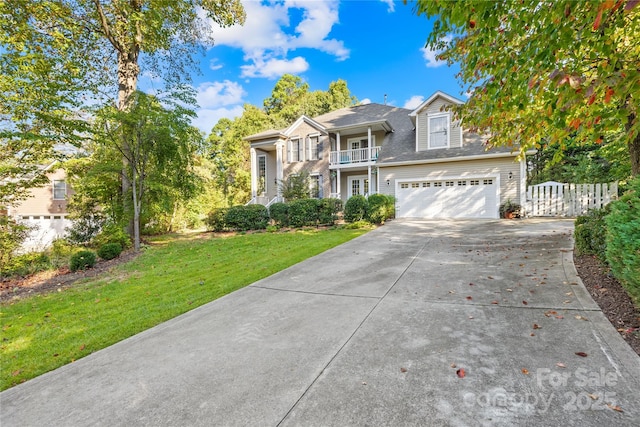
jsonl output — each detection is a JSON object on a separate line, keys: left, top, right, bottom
{"left": 525, "top": 182, "right": 618, "bottom": 217}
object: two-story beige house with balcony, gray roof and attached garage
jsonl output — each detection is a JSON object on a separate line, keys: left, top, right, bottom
{"left": 245, "top": 92, "right": 526, "bottom": 218}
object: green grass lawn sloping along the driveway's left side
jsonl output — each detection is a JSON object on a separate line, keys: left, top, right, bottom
{"left": 0, "top": 229, "right": 367, "bottom": 390}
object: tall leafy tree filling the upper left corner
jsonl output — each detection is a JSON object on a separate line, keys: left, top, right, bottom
{"left": 0, "top": 0, "right": 245, "bottom": 221}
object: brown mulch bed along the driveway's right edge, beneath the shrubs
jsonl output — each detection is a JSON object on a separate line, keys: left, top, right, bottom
{"left": 573, "top": 255, "right": 640, "bottom": 356}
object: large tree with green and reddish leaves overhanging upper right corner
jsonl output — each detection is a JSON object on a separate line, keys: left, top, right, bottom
{"left": 416, "top": 0, "right": 640, "bottom": 175}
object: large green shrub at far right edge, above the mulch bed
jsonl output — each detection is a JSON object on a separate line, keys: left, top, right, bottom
{"left": 606, "top": 177, "right": 640, "bottom": 304}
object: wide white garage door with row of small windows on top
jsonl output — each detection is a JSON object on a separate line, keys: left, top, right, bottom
{"left": 396, "top": 178, "right": 498, "bottom": 218}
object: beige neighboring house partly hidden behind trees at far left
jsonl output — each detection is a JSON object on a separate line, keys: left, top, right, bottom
{"left": 7, "top": 165, "right": 72, "bottom": 251}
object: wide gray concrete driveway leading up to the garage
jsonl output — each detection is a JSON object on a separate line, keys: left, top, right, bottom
{"left": 0, "top": 219, "right": 640, "bottom": 427}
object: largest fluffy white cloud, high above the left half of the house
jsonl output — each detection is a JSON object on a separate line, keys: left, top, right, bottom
{"left": 210, "top": 0, "right": 350, "bottom": 78}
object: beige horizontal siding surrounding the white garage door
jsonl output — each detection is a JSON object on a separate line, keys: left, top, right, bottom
{"left": 379, "top": 157, "right": 522, "bottom": 208}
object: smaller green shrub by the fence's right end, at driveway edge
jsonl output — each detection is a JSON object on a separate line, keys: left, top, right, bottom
{"left": 574, "top": 204, "right": 611, "bottom": 262}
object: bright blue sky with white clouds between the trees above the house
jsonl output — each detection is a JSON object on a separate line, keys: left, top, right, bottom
{"left": 178, "top": 0, "right": 465, "bottom": 134}
